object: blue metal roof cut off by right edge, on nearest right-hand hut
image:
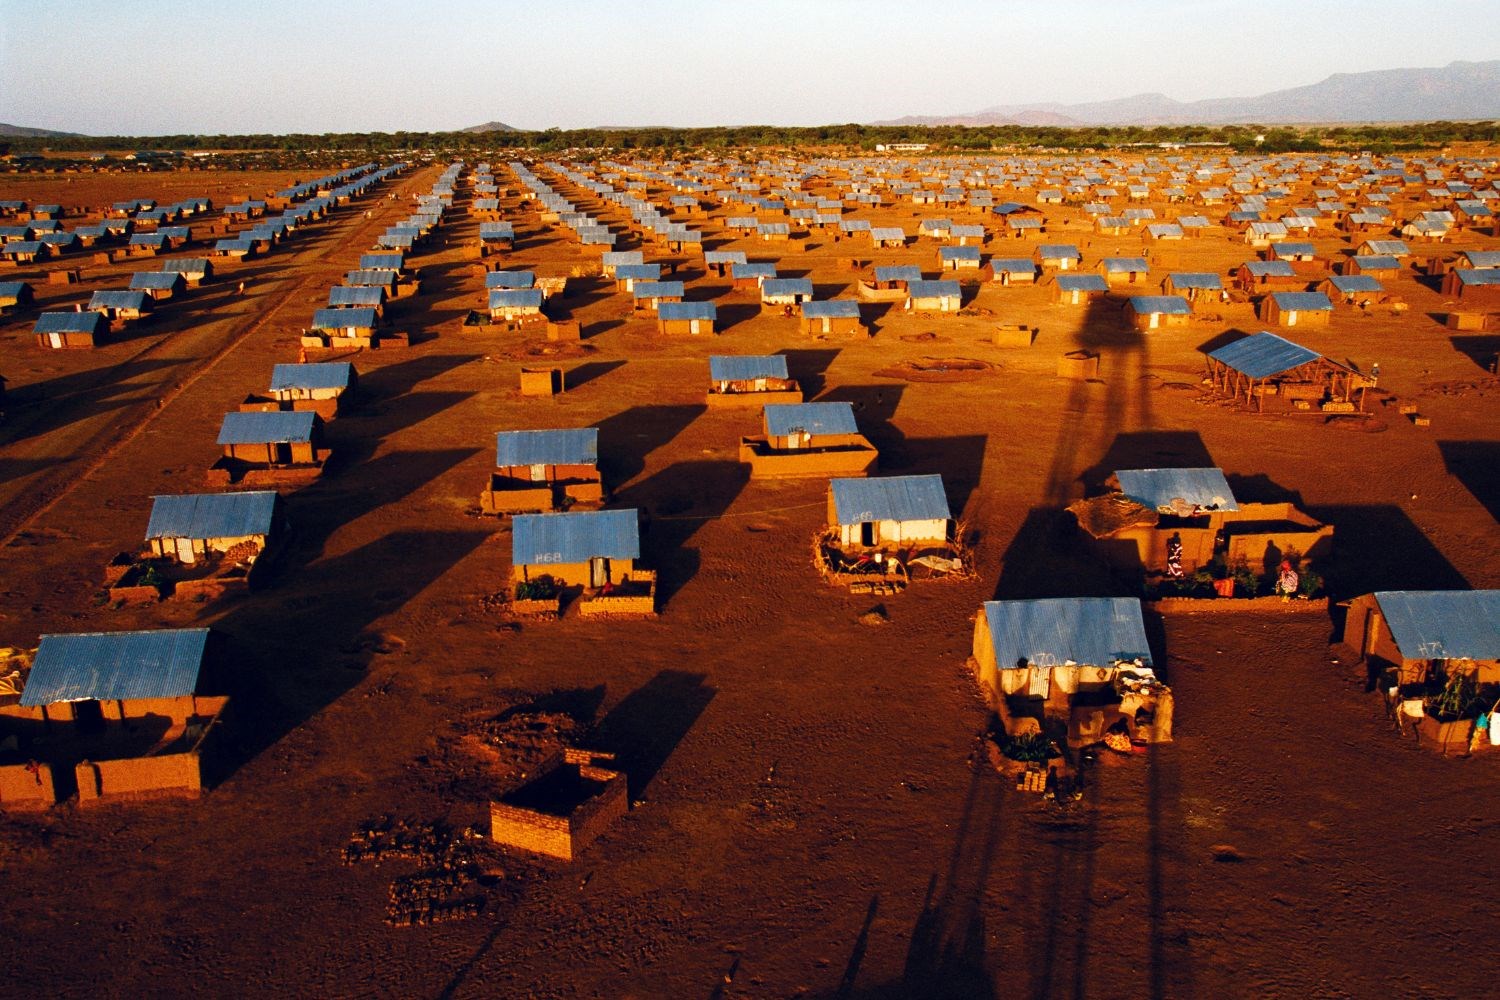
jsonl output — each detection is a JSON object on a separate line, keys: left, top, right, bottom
{"left": 1374, "top": 591, "right": 1500, "bottom": 660}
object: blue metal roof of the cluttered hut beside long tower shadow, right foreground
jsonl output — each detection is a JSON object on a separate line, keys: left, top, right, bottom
{"left": 984, "top": 597, "right": 1151, "bottom": 670}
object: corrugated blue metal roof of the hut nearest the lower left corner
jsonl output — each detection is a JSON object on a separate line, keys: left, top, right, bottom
{"left": 21, "top": 628, "right": 209, "bottom": 708}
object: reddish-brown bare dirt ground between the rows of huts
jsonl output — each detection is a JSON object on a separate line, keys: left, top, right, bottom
{"left": 0, "top": 162, "right": 1500, "bottom": 997}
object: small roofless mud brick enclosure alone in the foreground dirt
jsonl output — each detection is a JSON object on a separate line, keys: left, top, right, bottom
{"left": 489, "top": 750, "right": 630, "bottom": 861}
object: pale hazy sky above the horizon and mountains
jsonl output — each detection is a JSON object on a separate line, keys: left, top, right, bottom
{"left": 0, "top": 0, "right": 1500, "bottom": 135}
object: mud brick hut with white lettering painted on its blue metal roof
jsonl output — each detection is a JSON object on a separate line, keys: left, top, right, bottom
{"left": 510, "top": 508, "right": 656, "bottom": 615}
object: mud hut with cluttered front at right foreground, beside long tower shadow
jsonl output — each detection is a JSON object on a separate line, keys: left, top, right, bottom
{"left": 974, "top": 597, "right": 1172, "bottom": 747}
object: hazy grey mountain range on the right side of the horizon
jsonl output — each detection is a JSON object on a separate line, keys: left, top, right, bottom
{"left": 873, "top": 60, "right": 1500, "bottom": 127}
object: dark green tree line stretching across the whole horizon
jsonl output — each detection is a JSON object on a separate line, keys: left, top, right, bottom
{"left": 0, "top": 121, "right": 1500, "bottom": 154}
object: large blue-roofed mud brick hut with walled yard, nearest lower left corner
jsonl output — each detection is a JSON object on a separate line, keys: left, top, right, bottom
{"left": 0, "top": 628, "right": 228, "bottom": 808}
